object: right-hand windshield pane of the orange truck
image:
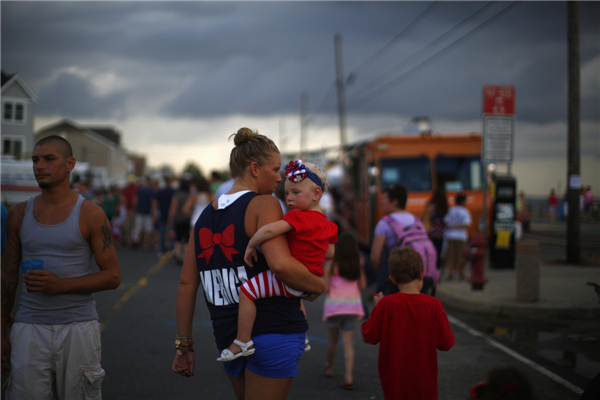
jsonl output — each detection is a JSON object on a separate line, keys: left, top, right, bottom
{"left": 435, "top": 156, "right": 483, "bottom": 192}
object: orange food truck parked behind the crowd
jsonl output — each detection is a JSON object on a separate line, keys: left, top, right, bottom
{"left": 340, "top": 133, "right": 489, "bottom": 247}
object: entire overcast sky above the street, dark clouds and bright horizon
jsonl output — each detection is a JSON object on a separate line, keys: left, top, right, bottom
{"left": 1, "top": 1, "right": 600, "bottom": 192}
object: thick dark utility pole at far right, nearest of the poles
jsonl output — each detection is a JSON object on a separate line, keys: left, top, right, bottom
{"left": 567, "top": 1, "right": 581, "bottom": 265}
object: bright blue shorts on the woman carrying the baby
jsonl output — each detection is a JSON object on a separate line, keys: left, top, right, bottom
{"left": 219, "top": 333, "right": 305, "bottom": 379}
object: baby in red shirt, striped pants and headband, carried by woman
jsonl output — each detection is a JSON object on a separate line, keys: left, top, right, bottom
{"left": 217, "top": 160, "right": 338, "bottom": 362}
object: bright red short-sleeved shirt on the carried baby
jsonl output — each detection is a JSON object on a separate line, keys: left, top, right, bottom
{"left": 283, "top": 210, "right": 337, "bottom": 276}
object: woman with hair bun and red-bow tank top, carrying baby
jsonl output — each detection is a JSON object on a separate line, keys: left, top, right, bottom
{"left": 173, "top": 128, "right": 324, "bottom": 400}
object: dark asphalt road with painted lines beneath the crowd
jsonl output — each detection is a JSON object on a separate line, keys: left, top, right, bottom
{"left": 89, "top": 248, "right": 600, "bottom": 400}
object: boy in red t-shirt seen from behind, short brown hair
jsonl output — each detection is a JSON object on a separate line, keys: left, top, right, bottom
{"left": 361, "top": 247, "right": 454, "bottom": 400}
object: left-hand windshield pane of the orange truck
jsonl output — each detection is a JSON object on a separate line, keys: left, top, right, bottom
{"left": 380, "top": 157, "right": 432, "bottom": 192}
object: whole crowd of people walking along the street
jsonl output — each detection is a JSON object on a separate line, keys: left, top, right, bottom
{"left": 1, "top": 128, "right": 568, "bottom": 399}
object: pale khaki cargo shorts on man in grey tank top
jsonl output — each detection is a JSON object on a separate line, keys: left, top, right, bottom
{"left": 5, "top": 321, "right": 105, "bottom": 400}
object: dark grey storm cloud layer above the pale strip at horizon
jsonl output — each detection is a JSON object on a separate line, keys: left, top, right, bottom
{"left": 1, "top": 2, "right": 600, "bottom": 122}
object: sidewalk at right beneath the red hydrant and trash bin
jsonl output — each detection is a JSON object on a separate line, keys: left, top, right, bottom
{"left": 436, "top": 264, "right": 600, "bottom": 319}
